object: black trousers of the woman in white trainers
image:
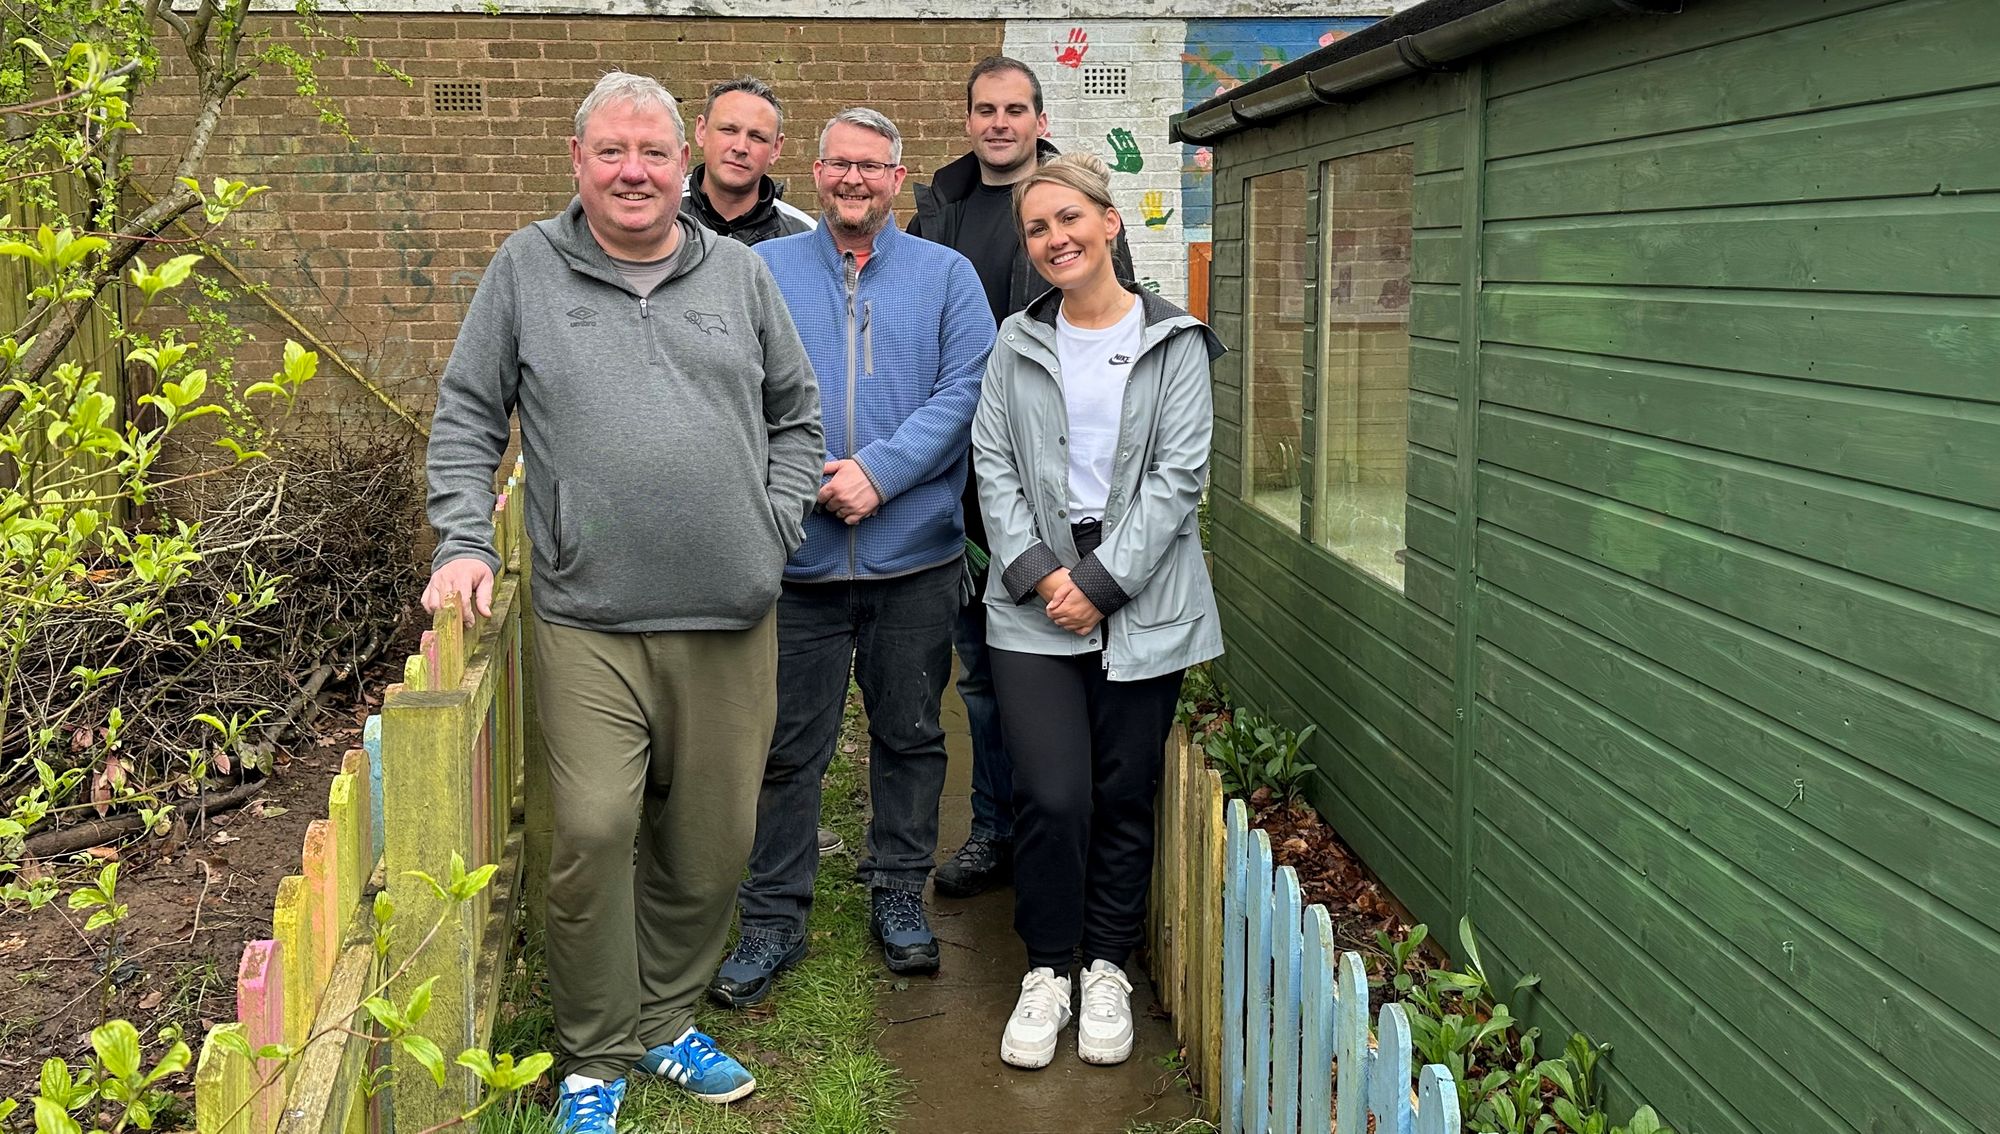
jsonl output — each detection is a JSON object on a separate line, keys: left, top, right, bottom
{"left": 990, "top": 650, "right": 1180, "bottom": 974}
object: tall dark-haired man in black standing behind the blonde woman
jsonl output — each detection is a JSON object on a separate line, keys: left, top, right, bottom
{"left": 908, "top": 56, "right": 1134, "bottom": 898}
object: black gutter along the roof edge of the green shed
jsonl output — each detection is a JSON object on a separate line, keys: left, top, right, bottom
{"left": 1168, "top": 0, "right": 1682, "bottom": 146}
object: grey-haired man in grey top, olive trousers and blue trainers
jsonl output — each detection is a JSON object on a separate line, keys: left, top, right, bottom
{"left": 424, "top": 72, "right": 824, "bottom": 1134}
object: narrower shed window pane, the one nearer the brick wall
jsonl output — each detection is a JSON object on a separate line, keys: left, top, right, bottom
{"left": 1244, "top": 168, "right": 1306, "bottom": 532}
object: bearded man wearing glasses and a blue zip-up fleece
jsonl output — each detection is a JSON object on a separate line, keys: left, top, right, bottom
{"left": 708, "top": 108, "right": 994, "bottom": 1008}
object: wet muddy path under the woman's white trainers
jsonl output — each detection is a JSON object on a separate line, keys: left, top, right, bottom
{"left": 876, "top": 692, "right": 1194, "bottom": 1134}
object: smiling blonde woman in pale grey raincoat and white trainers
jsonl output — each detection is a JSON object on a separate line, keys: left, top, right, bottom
{"left": 972, "top": 154, "right": 1222, "bottom": 1068}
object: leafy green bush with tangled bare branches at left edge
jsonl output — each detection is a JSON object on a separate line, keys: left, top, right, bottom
{"left": 0, "top": 0, "right": 414, "bottom": 868}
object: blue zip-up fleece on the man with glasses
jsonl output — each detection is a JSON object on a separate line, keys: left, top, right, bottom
{"left": 754, "top": 220, "right": 994, "bottom": 582}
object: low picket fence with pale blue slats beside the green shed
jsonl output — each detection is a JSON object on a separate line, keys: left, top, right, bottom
{"left": 1150, "top": 730, "right": 1460, "bottom": 1134}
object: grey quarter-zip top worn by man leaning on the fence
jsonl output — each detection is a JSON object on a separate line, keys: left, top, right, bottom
{"left": 428, "top": 200, "right": 826, "bottom": 632}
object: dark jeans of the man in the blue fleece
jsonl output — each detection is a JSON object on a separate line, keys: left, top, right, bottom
{"left": 736, "top": 560, "right": 964, "bottom": 942}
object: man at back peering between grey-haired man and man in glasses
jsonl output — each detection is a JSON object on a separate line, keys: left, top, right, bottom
{"left": 680, "top": 76, "right": 812, "bottom": 244}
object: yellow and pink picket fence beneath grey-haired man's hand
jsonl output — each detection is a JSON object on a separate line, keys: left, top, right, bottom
{"left": 194, "top": 464, "right": 532, "bottom": 1134}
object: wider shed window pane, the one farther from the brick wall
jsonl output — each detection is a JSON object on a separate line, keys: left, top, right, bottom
{"left": 1314, "top": 146, "right": 1414, "bottom": 588}
